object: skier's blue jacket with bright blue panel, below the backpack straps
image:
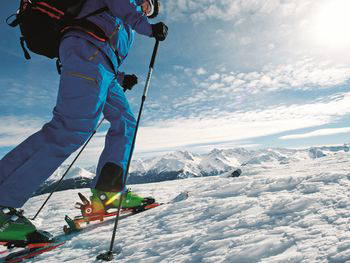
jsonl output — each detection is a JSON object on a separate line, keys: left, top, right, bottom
{"left": 63, "top": 0, "right": 152, "bottom": 84}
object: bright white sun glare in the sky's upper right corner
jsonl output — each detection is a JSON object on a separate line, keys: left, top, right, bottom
{"left": 309, "top": 0, "right": 350, "bottom": 49}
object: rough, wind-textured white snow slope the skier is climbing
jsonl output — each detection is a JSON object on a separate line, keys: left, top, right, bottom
{"left": 15, "top": 153, "right": 350, "bottom": 263}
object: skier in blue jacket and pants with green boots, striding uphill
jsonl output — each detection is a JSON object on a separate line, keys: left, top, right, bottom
{"left": 0, "top": 0, "right": 168, "bottom": 242}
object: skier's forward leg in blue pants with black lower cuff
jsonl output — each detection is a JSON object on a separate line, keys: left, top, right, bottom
{"left": 92, "top": 81, "right": 136, "bottom": 192}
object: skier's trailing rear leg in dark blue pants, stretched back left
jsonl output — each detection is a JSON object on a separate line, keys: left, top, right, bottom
{"left": 0, "top": 37, "right": 114, "bottom": 210}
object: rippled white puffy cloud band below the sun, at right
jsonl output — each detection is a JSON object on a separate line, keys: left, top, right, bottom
{"left": 166, "top": 59, "right": 350, "bottom": 105}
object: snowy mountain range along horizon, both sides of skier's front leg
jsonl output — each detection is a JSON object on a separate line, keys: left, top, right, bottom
{"left": 36, "top": 144, "right": 350, "bottom": 194}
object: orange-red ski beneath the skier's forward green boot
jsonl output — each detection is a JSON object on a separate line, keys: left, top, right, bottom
{"left": 63, "top": 203, "right": 162, "bottom": 234}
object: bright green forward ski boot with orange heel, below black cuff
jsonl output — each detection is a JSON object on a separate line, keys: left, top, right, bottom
{"left": 76, "top": 189, "right": 155, "bottom": 217}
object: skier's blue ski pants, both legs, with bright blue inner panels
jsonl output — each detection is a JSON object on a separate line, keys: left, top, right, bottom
{"left": 0, "top": 36, "right": 136, "bottom": 208}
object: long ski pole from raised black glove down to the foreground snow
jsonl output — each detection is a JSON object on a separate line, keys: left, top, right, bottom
{"left": 97, "top": 40, "right": 159, "bottom": 261}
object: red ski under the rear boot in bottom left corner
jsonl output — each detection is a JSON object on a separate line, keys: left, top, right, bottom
{"left": 0, "top": 242, "right": 65, "bottom": 263}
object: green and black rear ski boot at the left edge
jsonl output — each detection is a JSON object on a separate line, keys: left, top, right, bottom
{"left": 0, "top": 206, "right": 53, "bottom": 248}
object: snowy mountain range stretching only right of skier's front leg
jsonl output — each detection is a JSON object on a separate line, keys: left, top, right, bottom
{"left": 128, "top": 144, "right": 350, "bottom": 184}
